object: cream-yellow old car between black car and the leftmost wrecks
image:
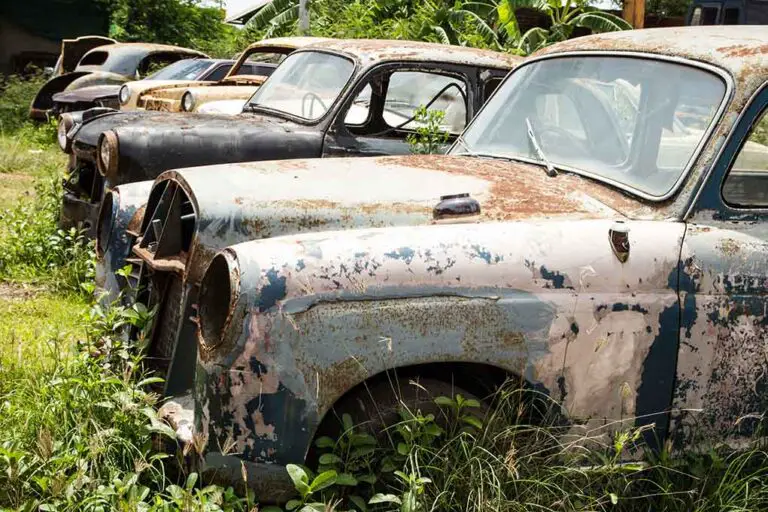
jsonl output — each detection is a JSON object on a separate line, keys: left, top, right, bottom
{"left": 120, "top": 37, "right": 325, "bottom": 115}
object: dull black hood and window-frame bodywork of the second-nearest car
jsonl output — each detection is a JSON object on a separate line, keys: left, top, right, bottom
{"left": 68, "top": 41, "right": 520, "bottom": 234}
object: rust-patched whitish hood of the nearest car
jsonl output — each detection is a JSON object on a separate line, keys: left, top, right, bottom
{"left": 144, "top": 155, "right": 653, "bottom": 281}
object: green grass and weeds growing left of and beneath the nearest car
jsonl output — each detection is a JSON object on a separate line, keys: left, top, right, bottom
{"left": 0, "top": 14, "right": 768, "bottom": 512}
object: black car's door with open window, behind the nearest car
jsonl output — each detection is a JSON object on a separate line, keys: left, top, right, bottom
{"left": 323, "top": 65, "right": 474, "bottom": 157}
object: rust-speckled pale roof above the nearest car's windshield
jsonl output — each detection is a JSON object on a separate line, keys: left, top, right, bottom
{"left": 535, "top": 25, "right": 768, "bottom": 82}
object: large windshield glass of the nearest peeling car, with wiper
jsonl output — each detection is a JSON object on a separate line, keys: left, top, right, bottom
{"left": 452, "top": 56, "right": 726, "bottom": 197}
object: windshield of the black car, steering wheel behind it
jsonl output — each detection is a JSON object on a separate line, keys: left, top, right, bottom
{"left": 246, "top": 52, "right": 355, "bottom": 120}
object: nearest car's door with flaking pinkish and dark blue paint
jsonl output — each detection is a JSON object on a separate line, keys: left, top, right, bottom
{"left": 674, "top": 84, "right": 768, "bottom": 445}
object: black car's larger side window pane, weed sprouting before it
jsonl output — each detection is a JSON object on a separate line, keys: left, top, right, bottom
{"left": 383, "top": 71, "right": 467, "bottom": 134}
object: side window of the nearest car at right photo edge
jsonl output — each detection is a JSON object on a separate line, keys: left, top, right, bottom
{"left": 723, "top": 109, "right": 768, "bottom": 208}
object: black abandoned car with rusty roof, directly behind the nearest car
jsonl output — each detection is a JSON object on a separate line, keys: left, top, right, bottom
{"left": 59, "top": 40, "right": 521, "bottom": 237}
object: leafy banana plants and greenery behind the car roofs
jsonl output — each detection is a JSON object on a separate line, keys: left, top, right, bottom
{"left": 248, "top": 0, "right": 631, "bottom": 54}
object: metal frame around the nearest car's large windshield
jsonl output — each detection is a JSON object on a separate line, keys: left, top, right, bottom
{"left": 446, "top": 50, "right": 735, "bottom": 203}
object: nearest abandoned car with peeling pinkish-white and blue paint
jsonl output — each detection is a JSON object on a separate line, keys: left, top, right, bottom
{"left": 102, "top": 27, "right": 768, "bottom": 499}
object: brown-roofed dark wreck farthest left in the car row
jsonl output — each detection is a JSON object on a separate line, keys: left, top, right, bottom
{"left": 29, "top": 40, "right": 208, "bottom": 121}
